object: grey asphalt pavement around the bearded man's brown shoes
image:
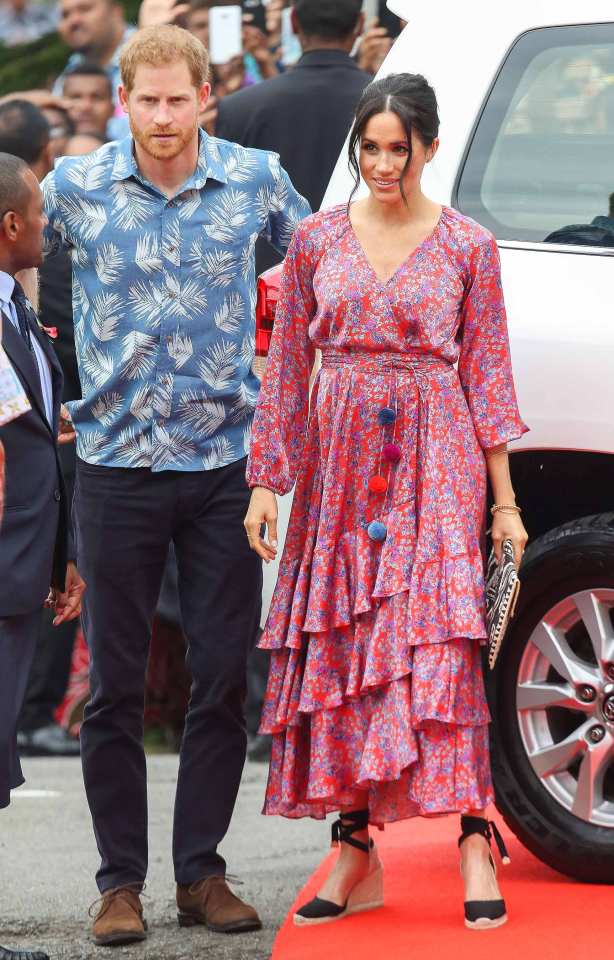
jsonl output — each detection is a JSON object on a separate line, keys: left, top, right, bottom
{"left": 0, "top": 755, "right": 327, "bottom": 960}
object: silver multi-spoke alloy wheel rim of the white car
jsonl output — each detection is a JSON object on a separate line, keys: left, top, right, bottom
{"left": 516, "top": 588, "right": 614, "bottom": 830}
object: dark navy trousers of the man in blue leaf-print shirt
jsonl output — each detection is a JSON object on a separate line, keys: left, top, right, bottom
{"left": 74, "top": 460, "right": 262, "bottom": 891}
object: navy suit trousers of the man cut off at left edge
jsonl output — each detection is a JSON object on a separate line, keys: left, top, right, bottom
{"left": 0, "top": 612, "right": 43, "bottom": 807}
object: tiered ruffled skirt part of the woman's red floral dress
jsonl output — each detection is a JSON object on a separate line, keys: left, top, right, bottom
{"left": 261, "top": 362, "right": 492, "bottom": 824}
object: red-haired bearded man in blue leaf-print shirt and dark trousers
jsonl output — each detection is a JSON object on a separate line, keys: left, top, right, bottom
{"left": 44, "top": 26, "right": 309, "bottom": 944}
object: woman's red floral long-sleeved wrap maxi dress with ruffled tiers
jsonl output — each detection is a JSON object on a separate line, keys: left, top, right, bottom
{"left": 248, "top": 207, "right": 527, "bottom": 824}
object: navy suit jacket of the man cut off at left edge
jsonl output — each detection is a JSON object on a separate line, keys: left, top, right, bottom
{"left": 0, "top": 296, "right": 72, "bottom": 617}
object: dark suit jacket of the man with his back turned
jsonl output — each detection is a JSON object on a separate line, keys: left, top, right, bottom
{"left": 215, "top": 50, "right": 373, "bottom": 272}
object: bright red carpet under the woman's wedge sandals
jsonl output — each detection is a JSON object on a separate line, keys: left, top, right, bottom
{"left": 271, "top": 817, "right": 614, "bottom": 960}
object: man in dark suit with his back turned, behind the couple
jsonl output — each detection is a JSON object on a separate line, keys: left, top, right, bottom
{"left": 215, "top": 0, "right": 373, "bottom": 272}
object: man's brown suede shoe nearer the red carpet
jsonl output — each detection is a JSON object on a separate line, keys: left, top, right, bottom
{"left": 177, "top": 876, "right": 262, "bottom": 933}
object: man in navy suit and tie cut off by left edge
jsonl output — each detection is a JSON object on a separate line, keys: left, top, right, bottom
{"left": 0, "top": 153, "right": 85, "bottom": 960}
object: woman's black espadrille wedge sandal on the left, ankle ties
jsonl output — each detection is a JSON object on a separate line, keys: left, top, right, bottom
{"left": 294, "top": 810, "right": 384, "bottom": 926}
